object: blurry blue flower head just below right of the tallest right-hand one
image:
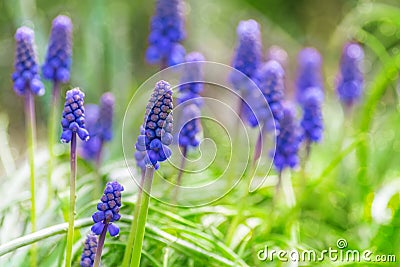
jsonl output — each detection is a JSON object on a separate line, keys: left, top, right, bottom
{"left": 255, "top": 60, "right": 285, "bottom": 131}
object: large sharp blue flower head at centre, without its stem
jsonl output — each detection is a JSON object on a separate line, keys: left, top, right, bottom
{"left": 135, "top": 81, "right": 173, "bottom": 169}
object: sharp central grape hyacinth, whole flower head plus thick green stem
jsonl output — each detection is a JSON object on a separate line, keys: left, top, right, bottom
{"left": 122, "top": 81, "right": 173, "bottom": 267}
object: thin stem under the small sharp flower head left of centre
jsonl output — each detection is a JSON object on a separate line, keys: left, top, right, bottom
{"left": 65, "top": 133, "right": 76, "bottom": 267}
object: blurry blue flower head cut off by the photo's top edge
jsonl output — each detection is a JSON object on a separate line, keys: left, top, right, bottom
{"left": 146, "top": 0, "right": 186, "bottom": 66}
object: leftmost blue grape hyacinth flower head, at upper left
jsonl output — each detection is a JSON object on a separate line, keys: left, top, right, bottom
{"left": 12, "top": 26, "right": 44, "bottom": 96}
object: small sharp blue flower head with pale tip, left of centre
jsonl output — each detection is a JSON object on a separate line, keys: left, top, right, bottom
{"left": 61, "top": 88, "right": 89, "bottom": 143}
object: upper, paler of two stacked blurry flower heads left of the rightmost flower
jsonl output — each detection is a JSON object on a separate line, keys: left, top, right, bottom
{"left": 296, "top": 47, "right": 323, "bottom": 104}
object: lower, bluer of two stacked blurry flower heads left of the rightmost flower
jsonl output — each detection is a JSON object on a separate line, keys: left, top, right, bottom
{"left": 301, "top": 87, "right": 324, "bottom": 142}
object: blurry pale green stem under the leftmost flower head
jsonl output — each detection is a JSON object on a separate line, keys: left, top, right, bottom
{"left": 25, "top": 90, "right": 37, "bottom": 267}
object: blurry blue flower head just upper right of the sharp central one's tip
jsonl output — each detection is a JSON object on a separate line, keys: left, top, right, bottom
{"left": 177, "top": 52, "right": 205, "bottom": 107}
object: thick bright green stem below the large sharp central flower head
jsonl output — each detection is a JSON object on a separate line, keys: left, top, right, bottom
{"left": 130, "top": 167, "right": 154, "bottom": 267}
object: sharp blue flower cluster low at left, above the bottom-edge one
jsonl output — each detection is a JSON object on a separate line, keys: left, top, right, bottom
{"left": 91, "top": 181, "right": 124, "bottom": 236}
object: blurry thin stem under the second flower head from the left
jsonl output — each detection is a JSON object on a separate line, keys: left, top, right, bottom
{"left": 47, "top": 82, "right": 60, "bottom": 207}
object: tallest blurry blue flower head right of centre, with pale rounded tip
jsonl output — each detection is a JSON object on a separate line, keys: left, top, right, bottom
{"left": 230, "top": 19, "right": 262, "bottom": 91}
